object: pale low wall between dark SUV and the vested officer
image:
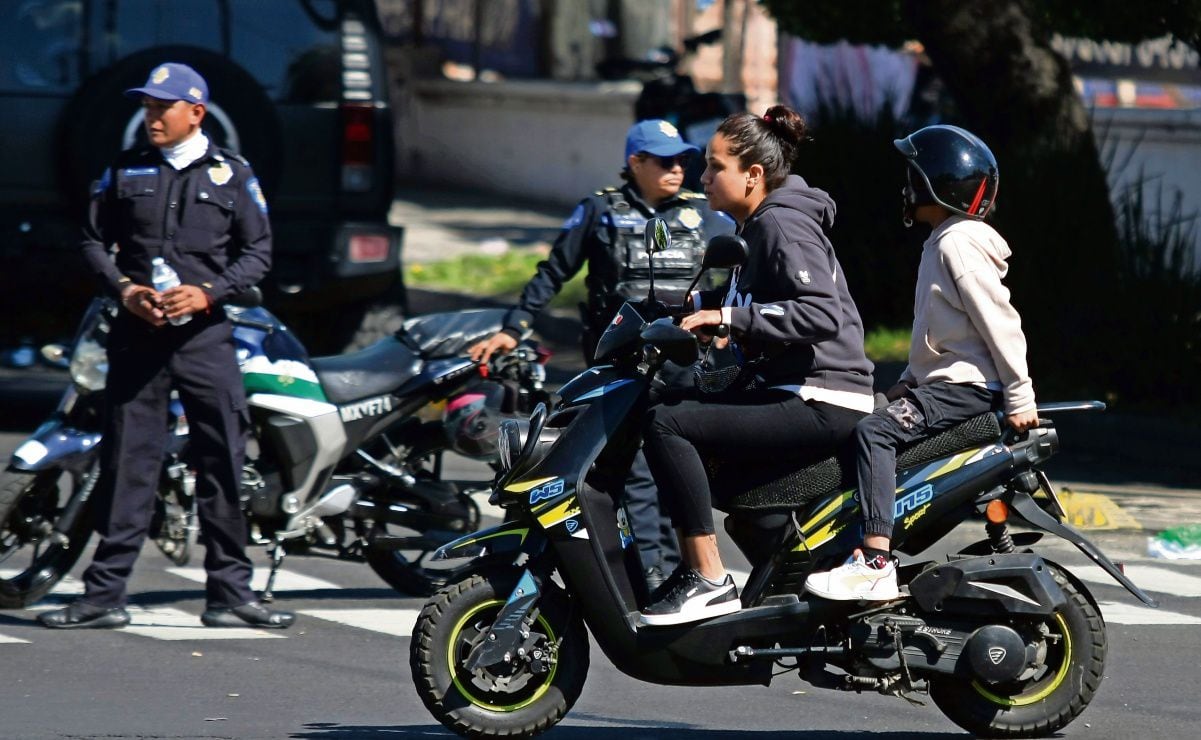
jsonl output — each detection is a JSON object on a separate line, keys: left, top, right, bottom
{"left": 398, "top": 79, "right": 640, "bottom": 205}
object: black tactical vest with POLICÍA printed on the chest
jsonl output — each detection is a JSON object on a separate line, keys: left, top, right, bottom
{"left": 588, "top": 191, "right": 709, "bottom": 319}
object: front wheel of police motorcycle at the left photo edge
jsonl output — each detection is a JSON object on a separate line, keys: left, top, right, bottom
{"left": 0, "top": 464, "right": 100, "bottom": 609}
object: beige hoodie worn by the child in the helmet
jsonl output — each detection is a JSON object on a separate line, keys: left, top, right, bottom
{"left": 901, "top": 216, "right": 1034, "bottom": 413}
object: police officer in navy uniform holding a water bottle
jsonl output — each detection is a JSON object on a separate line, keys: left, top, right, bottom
{"left": 38, "top": 64, "right": 294, "bottom": 628}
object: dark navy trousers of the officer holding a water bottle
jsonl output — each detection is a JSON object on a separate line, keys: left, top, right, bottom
{"left": 83, "top": 314, "right": 255, "bottom": 608}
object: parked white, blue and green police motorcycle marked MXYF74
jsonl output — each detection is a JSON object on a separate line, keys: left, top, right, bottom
{"left": 0, "top": 291, "right": 549, "bottom": 608}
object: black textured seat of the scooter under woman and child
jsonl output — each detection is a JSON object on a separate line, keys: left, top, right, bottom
{"left": 705, "top": 412, "right": 1000, "bottom": 512}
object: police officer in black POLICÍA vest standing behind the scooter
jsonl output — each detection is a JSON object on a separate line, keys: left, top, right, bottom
{"left": 468, "top": 120, "right": 734, "bottom": 590}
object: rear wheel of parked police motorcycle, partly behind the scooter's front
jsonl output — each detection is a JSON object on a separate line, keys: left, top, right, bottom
{"left": 366, "top": 494, "right": 479, "bottom": 596}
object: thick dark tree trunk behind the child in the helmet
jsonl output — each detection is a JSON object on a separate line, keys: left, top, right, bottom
{"left": 904, "top": 0, "right": 1118, "bottom": 398}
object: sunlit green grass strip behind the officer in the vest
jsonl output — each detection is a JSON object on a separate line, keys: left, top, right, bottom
{"left": 405, "top": 250, "right": 587, "bottom": 309}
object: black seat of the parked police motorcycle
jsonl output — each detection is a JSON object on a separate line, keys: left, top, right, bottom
{"left": 312, "top": 336, "right": 422, "bottom": 404}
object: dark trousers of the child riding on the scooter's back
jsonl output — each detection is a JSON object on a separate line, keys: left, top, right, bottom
{"left": 855, "top": 383, "right": 1000, "bottom": 538}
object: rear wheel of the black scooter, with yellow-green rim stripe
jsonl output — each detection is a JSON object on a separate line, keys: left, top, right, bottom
{"left": 930, "top": 565, "right": 1106, "bottom": 738}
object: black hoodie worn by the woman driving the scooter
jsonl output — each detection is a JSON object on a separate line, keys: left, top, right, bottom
{"left": 701, "top": 175, "right": 872, "bottom": 396}
